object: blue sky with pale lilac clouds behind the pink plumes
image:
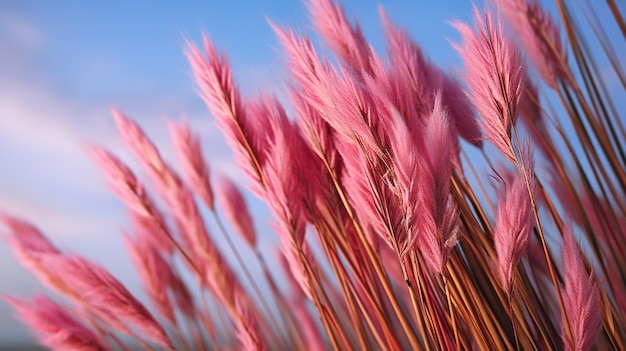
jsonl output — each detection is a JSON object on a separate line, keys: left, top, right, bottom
{"left": 0, "top": 0, "right": 616, "bottom": 342}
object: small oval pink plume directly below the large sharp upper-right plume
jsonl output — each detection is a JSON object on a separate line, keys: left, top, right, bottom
{"left": 494, "top": 166, "right": 534, "bottom": 294}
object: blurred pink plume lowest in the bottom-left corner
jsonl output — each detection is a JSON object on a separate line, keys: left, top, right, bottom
{"left": 5, "top": 295, "right": 109, "bottom": 351}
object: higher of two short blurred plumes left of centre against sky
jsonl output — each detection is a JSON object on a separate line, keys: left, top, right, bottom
{"left": 170, "top": 121, "right": 215, "bottom": 211}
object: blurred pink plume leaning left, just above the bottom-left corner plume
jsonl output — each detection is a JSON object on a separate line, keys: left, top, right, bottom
{"left": 42, "top": 256, "right": 173, "bottom": 349}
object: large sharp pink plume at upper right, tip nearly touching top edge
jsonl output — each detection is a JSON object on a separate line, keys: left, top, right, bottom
{"left": 454, "top": 8, "right": 527, "bottom": 164}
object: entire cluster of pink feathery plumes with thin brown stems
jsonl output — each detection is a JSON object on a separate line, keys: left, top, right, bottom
{"left": 1, "top": 0, "right": 626, "bottom": 351}
